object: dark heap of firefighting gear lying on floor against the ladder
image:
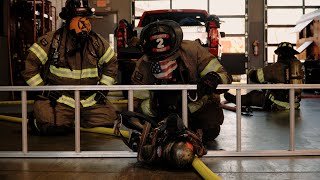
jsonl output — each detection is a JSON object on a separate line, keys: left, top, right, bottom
{"left": 116, "top": 111, "right": 207, "bottom": 168}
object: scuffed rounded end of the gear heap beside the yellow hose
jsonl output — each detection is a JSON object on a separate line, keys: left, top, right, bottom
{"left": 163, "top": 141, "right": 195, "bottom": 168}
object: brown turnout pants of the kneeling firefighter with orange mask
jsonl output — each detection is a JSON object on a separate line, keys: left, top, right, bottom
{"left": 34, "top": 100, "right": 118, "bottom": 134}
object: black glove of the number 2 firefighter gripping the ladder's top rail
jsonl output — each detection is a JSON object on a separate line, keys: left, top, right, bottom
{"left": 197, "top": 72, "right": 220, "bottom": 97}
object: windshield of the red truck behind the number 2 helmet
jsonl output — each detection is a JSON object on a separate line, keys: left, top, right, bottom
{"left": 140, "top": 12, "right": 206, "bottom": 27}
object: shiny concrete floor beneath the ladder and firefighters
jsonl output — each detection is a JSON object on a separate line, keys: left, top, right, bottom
{"left": 0, "top": 92, "right": 320, "bottom": 180}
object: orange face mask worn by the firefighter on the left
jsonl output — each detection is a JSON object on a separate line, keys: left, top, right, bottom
{"left": 69, "top": 16, "right": 91, "bottom": 38}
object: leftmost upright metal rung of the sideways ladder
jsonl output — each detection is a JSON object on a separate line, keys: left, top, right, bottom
{"left": 21, "top": 91, "right": 28, "bottom": 154}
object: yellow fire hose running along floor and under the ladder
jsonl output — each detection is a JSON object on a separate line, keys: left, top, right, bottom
{"left": 0, "top": 115, "right": 221, "bottom": 180}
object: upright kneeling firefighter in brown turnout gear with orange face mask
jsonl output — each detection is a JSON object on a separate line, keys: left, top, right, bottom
{"left": 22, "top": 0, "right": 118, "bottom": 135}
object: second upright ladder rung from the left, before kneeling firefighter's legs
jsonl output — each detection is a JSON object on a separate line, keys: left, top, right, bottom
{"left": 74, "top": 90, "right": 80, "bottom": 153}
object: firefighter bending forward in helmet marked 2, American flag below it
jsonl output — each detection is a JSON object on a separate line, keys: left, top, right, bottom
{"left": 131, "top": 20, "right": 232, "bottom": 144}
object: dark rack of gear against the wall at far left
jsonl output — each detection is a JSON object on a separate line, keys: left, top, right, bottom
{"left": 8, "top": 0, "right": 57, "bottom": 94}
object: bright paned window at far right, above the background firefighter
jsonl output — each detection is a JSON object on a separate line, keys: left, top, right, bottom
{"left": 265, "top": 0, "right": 320, "bottom": 63}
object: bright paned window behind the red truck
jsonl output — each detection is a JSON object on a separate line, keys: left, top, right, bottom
{"left": 134, "top": 0, "right": 247, "bottom": 53}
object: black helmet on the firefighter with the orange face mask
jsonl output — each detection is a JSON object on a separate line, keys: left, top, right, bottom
{"left": 59, "top": 0, "right": 95, "bottom": 20}
